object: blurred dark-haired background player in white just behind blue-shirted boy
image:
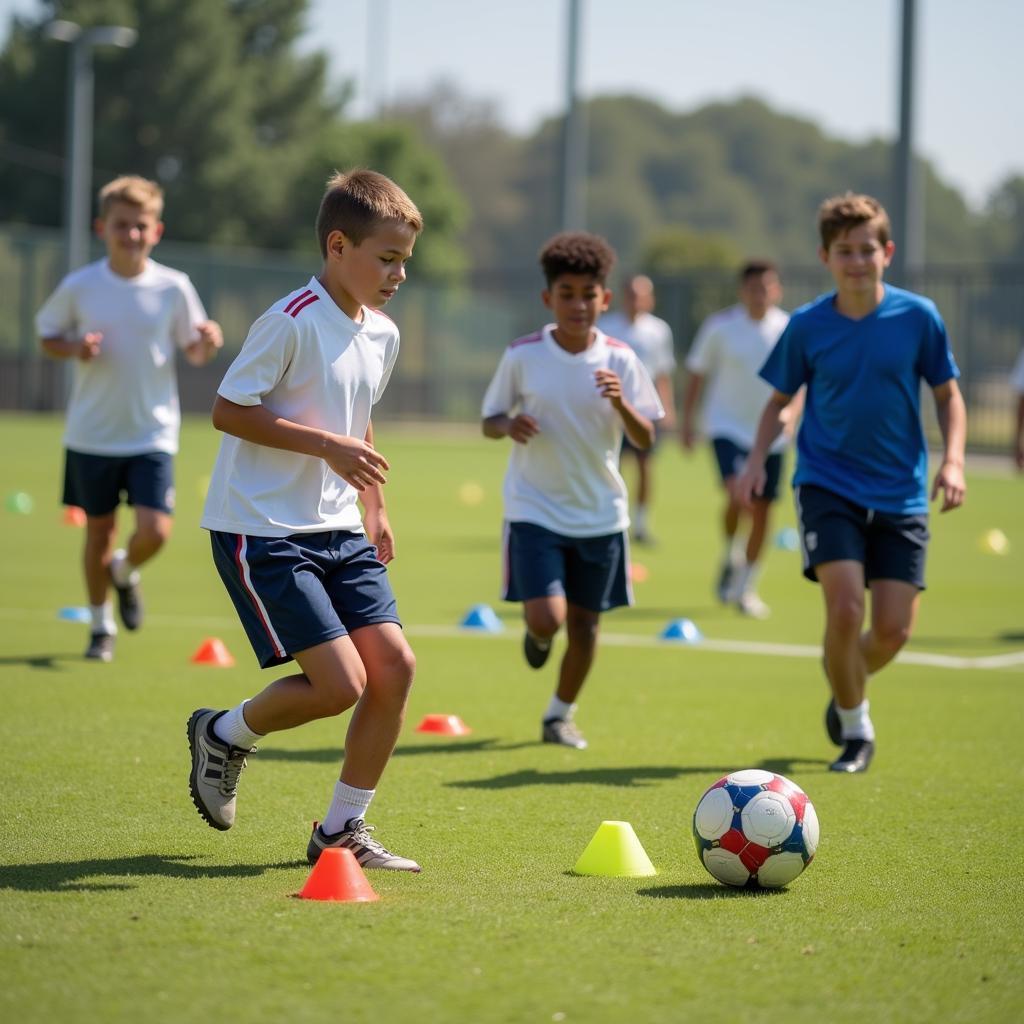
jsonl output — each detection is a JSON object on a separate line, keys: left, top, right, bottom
{"left": 681, "top": 260, "right": 800, "bottom": 618}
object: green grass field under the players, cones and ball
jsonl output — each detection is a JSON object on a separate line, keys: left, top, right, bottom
{"left": 0, "top": 416, "right": 1024, "bottom": 1024}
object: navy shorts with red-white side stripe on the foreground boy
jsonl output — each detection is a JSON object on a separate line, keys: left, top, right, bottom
{"left": 210, "top": 530, "right": 401, "bottom": 669}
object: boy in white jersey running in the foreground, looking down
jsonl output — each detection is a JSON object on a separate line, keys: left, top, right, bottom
{"left": 188, "top": 171, "right": 423, "bottom": 871}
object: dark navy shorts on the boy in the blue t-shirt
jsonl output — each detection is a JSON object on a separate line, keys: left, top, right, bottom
{"left": 794, "top": 483, "right": 929, "bottom": 590}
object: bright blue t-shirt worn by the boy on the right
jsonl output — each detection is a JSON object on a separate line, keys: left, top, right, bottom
{"left": 761, "top": 285, "right": 959, "bottom": 515}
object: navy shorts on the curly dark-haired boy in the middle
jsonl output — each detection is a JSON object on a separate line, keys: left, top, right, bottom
{"left": 502, "top": 522, "right": 633, "bottom": 611}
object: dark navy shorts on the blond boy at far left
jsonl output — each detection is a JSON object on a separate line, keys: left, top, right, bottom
{"left": 63, "top": 449, "right": 174, "bottom": 516}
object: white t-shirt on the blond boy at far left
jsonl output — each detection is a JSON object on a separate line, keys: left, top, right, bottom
{"left": 36, "top": 259, "right": 206, "bottom": 456}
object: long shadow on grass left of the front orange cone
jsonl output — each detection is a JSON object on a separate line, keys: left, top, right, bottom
{"left": 0, "top": 853, "right": 308, "bottom": 892}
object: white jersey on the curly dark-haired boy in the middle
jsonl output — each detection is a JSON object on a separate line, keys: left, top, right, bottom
{"left": 482, "top": 324, "right": 665, "bottom": 537}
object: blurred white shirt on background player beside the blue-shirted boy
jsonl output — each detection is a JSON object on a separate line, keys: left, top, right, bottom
{"left": 686, "top": 305, "right": 790, "bottom": 452}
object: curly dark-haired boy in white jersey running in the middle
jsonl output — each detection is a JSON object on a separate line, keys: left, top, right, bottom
{"left": 482, "top": 231, "right": 665, "bottom": 750}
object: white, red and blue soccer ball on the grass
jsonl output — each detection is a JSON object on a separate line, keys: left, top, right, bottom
{"left": 693, "top": 768, "right": 818, "bottom": 889}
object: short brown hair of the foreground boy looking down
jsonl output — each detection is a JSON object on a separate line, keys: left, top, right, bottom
{"left": 316, "top": 169, "right": 423, "bottom": 258}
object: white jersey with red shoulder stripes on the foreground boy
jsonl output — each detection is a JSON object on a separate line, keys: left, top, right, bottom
{"left": 200, "top": 278, "right": 398, "bottom": 537}
